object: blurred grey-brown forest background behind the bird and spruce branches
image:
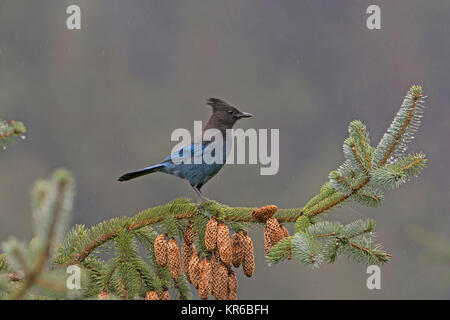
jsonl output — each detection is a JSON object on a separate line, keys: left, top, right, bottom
{"left": 0, "top": 0, "right": 450, "bottom": 299}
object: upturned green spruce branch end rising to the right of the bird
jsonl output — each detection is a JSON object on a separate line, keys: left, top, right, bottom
{"left": 304, "top": 85, "right": 426, "bottom": 217}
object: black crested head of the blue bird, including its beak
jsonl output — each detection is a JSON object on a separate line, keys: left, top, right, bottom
{"left": 205, "top": 98, "right": 253, "bottom": 130}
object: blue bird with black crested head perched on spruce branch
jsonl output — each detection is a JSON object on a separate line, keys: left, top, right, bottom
{"left": 118, "top": 98, "right": 253, "bottom": 203}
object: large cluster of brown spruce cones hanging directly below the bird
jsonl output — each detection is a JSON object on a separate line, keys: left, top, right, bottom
{"left": 149, "top": 217, "right": 255, "bottom": 300}
